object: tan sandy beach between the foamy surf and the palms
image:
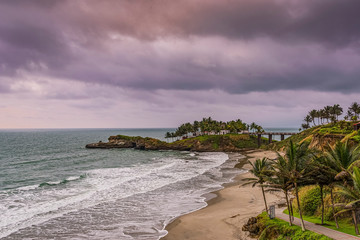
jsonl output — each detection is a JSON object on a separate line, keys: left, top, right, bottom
{"left": 162, "top": 150, "right": 282, "bottom": 240}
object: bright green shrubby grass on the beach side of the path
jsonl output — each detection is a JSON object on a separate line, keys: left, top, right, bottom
{"left": 258, "top": 212, "right": 332, "bottom": 240}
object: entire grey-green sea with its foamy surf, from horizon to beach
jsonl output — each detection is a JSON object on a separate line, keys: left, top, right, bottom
{"left": 0, "top": 129, "right": 297, "bottom": 239}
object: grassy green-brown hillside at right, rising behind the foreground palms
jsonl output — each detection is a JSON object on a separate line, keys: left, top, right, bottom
{"left": 267, "top": 121, "right": 360, "bottom": 150}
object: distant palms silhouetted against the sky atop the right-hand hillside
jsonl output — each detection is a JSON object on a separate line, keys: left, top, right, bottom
{"left": 301, "top": 102, "right": 360, "bottom": 129}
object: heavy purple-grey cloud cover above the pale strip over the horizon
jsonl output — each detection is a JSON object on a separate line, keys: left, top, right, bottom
{"left": 0, "top": 0, "right": 360, "bottom": 128}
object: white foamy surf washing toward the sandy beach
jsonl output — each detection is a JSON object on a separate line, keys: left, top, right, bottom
{"left": 0, "top": 153, "right": 239, "bottom": 239}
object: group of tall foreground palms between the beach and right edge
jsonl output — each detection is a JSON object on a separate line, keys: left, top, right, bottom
{"left": 244, "top": 141, "right": 360, "bottom": 234}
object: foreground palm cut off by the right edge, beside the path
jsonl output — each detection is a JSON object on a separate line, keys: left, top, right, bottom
{"left": 337, "top": 167, "right": 360, "bottom": 235}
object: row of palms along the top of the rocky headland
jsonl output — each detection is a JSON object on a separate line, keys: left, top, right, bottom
{"left": 165, "top": 117, "right": 264, "bottom": 142}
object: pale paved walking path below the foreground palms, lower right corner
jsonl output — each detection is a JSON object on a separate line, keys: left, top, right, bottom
{"left": 276, "top": 209, "right": 360, "bottom": 240}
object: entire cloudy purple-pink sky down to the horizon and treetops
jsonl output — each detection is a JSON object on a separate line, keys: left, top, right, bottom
{"left": 0, "top": 0, "right": 360, "bottom": 128}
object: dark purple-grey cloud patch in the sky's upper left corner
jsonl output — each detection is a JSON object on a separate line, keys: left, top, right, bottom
{"left": 0, "top": 2, "right": 72, "bottom": 75}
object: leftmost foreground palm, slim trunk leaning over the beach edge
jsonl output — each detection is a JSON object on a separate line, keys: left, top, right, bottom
{"left": 243, "top": 158, "right": 272, "bottom": 213}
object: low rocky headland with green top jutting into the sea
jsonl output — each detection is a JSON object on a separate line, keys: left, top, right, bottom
{"left": 86, "top": 134, "right": 258, "bottom": 152}
